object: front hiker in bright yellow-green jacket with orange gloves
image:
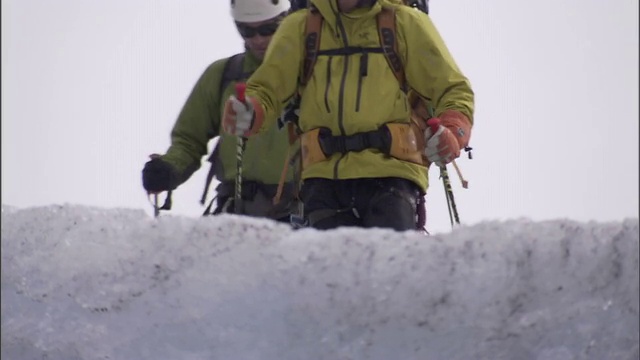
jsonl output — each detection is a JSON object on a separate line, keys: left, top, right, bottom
{"left": 223, "top": 0, "right": 474, "bottom": 230}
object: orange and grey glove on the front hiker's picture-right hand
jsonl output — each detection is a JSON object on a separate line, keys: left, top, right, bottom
{"left": 424, "top": 110, "right": 471, "bottom": 166}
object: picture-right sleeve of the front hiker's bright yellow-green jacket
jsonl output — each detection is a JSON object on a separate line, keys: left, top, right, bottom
{"left": 396, "top": 8, "right": 474, "bottom": 124}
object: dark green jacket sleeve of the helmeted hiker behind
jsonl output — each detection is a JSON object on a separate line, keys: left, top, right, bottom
{"left": 162, "top": 60, "right": 225, "bottom": 184}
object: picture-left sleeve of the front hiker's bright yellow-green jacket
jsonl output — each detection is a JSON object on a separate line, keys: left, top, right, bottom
{"left": 246, "top": 11, "right": 306, "bottom": 132}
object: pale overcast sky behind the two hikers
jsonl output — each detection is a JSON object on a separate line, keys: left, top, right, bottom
{"left": 2, "top": 0, "right": 639, "bottom": 231}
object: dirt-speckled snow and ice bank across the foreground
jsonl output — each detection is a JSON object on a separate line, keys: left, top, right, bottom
{"left": 1, "top": 205, "right": 640, "bottom": 360}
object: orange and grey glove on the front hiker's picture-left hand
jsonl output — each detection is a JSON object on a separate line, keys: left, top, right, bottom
{"left": 222, "top": 95, "right": 264, "bottom": 138}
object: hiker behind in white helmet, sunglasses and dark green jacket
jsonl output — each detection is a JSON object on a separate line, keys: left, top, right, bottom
{"left": 142, "top": 0, "right": 295, "bottom": 221}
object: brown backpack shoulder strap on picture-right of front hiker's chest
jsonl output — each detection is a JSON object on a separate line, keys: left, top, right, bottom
{"left": 377, "top": 6, "right": 407, "bottom": 91}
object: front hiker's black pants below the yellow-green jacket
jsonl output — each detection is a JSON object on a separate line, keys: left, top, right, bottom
{"left": 301, "top": 178, "right": 420, "bottom": 231}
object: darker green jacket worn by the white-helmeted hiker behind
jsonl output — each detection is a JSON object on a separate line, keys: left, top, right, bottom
{"left": 162, "top": 52, "right": 292, "bottom": 185}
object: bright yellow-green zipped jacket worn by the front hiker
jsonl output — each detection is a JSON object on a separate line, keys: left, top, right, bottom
{"left": 246, "top": 0, "right": 474, "bottom": 191}
